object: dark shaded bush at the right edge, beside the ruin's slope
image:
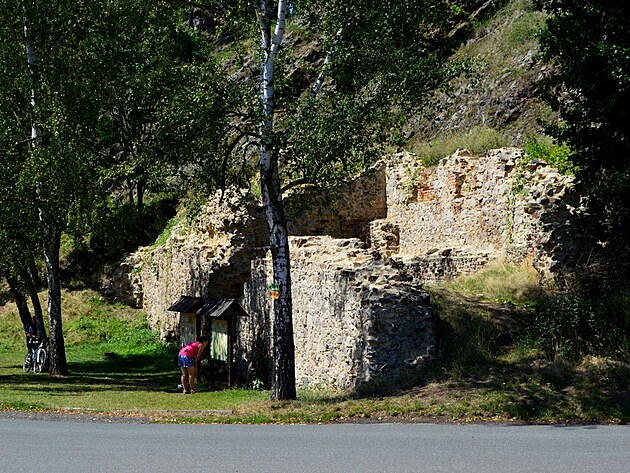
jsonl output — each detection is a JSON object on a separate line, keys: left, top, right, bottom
{"left": 529, "top": 270, "right": 630, "bottom": 361}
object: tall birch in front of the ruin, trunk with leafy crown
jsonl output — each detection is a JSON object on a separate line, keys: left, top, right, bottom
{"left": 202, "top": 0, "right": 479, "bottom": 399}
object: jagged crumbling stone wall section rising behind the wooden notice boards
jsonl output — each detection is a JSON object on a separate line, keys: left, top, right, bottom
{"left": 108, "top": 189, "right": 268, "bottom": 340}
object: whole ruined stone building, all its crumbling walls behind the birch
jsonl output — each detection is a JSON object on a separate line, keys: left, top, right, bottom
{"left": 113, "top": 148, "right": 580, "bottom": 388}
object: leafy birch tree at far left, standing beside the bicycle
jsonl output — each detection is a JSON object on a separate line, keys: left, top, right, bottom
{"left": 0, "top": 0, "right": 136, "bottom": 375}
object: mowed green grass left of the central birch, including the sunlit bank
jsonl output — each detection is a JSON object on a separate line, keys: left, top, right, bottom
{"left": 0, "top": 291, "right": 268, "bottom": 414}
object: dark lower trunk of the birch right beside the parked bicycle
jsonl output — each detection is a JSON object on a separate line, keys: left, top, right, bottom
{"left": 42, "top": 222, "right": 68, "bottom": 375}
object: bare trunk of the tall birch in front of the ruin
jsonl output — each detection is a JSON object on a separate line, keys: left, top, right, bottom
{"left": 257, "top": 0, "right": 296, "bottom": 400}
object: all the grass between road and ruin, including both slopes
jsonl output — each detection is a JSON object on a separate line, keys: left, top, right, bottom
{"left": 0, "top": 282, "right": 630, "bottom": 423}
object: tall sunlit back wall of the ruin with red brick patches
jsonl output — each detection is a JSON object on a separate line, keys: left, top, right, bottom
{"left": 371, "top": 148, "right": 582, "bottom": 272}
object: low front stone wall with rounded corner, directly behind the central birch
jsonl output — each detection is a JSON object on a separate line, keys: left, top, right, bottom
{"left": 237, "top": 237, "right": 435, "bottom": 389}
